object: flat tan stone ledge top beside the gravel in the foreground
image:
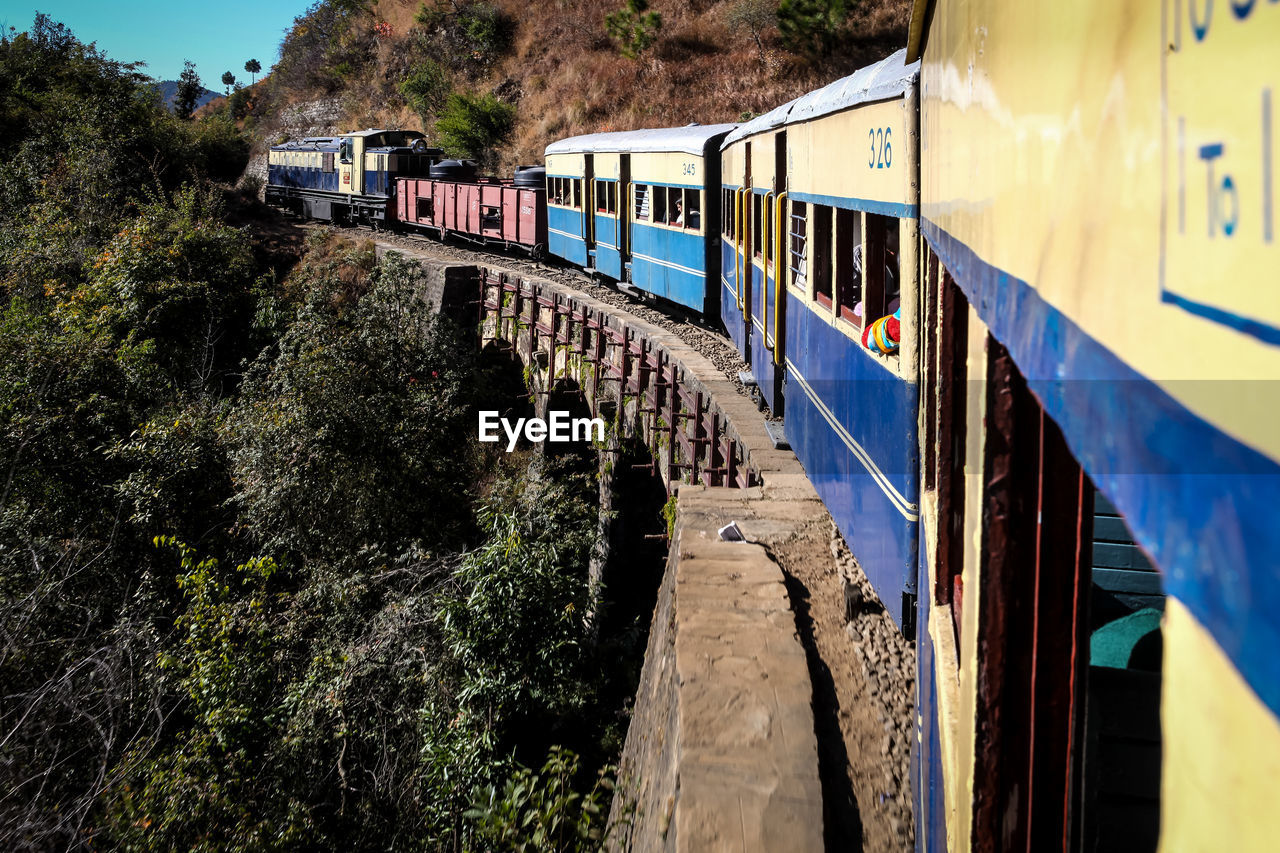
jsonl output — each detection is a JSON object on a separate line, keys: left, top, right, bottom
{"left": 612, "top": 485, "right": 823, "bottom": 853}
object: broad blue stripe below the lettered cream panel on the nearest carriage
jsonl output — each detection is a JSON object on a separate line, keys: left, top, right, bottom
{"left": 923, "top": 219, "right": 1280, "bottom": 713}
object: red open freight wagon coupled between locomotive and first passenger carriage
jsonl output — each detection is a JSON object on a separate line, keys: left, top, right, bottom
{"left": 396, "top": 160, "right": 547, "bottom": 257}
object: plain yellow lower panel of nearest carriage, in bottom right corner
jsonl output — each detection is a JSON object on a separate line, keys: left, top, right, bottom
{"left": 1160, "top": 598, "right": 1280, "bottom": 853}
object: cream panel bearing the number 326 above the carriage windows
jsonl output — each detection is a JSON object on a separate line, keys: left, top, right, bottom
{"left": 787, "top": 100, "right": 915, "bottom": 204}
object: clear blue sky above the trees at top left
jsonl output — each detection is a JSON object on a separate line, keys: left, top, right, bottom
{"left": 0, "top": 0, "right": 311, "bottom": 85}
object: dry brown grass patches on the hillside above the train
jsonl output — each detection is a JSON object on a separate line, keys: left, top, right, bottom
{"left": 264, "top": 0, "right": 911, "bottom": 169}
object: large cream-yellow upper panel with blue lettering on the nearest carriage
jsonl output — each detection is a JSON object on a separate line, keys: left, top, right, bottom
{"left": 920, "top": 0, "right": 1280, "bottom": 457}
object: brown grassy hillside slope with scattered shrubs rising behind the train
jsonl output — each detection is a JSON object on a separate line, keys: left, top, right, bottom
{"left": 250, "top": 0, "right": 911, "bottom": 170}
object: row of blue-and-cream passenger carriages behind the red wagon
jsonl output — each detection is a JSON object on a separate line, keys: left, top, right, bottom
{"left": 273, "top": 9, "right": 1280, "bottom": 852}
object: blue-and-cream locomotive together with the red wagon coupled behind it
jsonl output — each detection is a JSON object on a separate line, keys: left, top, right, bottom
{"left": 265, "top": 129, "right": 547, "bottom": 251}
